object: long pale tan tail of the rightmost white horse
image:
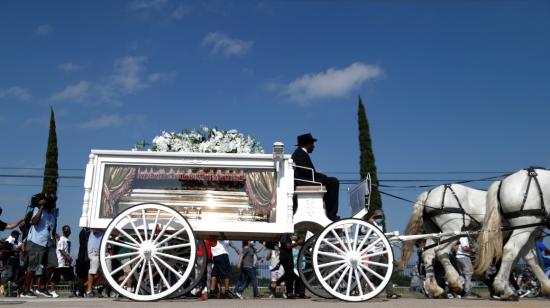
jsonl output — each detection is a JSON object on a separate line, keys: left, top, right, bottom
{"left": 474, "top": 182, "right": 502, "bottom": 274}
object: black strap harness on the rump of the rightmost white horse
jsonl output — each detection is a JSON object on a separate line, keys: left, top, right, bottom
{"left": 497, "top": 167, "right": 550, "bottom": 226}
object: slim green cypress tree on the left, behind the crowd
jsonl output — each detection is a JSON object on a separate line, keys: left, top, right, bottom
{"left": 42, "top": 108, "right": 59, "bottom": 195}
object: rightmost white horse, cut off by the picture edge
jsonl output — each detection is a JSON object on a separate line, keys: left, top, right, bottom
{"left": 475, "top": 168, "right": 550, "bottom": 300}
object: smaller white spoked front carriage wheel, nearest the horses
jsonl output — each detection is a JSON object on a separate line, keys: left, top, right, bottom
{"left": 313, "top": 219, "right": 393, "bottom": 302}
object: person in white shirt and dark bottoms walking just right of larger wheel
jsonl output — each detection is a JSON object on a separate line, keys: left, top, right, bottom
{"left": 208, "top": 236, "right": 241, "bottom": 298}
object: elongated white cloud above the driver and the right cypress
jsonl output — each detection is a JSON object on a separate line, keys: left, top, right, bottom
{"left": 280, "top": 62, "right": 384, "bottom": 104}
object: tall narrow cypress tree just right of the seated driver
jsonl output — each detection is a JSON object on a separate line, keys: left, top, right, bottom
{"left": 357, "top": 96, "right": 382, "bottom": 215}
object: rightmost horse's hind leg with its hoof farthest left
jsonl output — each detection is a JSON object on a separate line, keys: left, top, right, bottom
{"left": 493, "top": 228, "right": 536, "bottom": 300}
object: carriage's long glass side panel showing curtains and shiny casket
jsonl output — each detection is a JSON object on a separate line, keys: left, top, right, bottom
{"left": 99, "top": 164, "right": 277, "bottom": 221}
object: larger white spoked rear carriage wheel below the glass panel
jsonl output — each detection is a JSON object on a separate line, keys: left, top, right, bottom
{"left": 100, "top": 203, "right": 197, "bottom": 301}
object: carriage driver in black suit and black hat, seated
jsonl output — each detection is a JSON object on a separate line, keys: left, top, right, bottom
{"left": 292, "top": 133, "right": 340, "bottom": 221}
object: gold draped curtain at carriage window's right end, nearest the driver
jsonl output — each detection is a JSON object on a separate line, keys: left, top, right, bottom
{"left": 245, "top": 171, "right": 277, "bottom": 214}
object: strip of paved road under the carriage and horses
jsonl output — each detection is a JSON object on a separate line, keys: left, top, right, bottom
{"left": 0, "top": 298, "right": 550, "bottom": 308}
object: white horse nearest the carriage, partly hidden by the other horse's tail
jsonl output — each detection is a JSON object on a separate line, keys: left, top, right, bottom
{"left": 400, "top": 184, "right": 486, "bottom": 298}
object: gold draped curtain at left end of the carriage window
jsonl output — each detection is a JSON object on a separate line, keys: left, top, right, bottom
{"left": 101, "top": 166, "right": 136, "bottom": 218}
